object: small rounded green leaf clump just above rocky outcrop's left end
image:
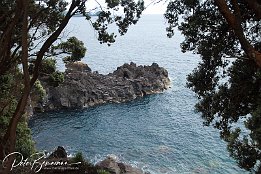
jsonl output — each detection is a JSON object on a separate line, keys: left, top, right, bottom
{"left": 52, "top": 37, "right": 86, "bottom": 63}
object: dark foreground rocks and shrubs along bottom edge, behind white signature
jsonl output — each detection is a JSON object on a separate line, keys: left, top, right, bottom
{"left": 11, "top": 146, "right": 145, "bottom": 174}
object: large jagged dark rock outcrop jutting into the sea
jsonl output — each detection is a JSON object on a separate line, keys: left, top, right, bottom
{"left": 41, "top": 63, "right": 170, "bottom": 110}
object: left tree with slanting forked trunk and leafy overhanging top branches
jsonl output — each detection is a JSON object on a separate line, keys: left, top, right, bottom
{"left": 0, "top": 0, "right": 144, "bottom": 173}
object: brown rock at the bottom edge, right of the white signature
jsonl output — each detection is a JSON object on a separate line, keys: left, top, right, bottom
{"left": 96, "top": 157, "right": 143, "bottom": 174}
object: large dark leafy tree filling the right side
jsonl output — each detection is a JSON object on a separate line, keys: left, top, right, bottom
{"left": 165, "top": 0, "right": 261, "bottom": 173}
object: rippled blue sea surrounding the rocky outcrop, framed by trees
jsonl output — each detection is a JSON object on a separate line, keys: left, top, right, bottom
{"left": 30, "top": 15, "right": 246, "bottom": 174}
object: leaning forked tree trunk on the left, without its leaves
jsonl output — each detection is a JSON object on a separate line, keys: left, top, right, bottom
{"left": 0, "top": 0, "right": 80, "bottom": 174}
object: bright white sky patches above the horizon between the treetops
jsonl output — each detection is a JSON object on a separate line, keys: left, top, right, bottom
{"left": 83, "top": 0, "right": 167, "bottom": 14}
